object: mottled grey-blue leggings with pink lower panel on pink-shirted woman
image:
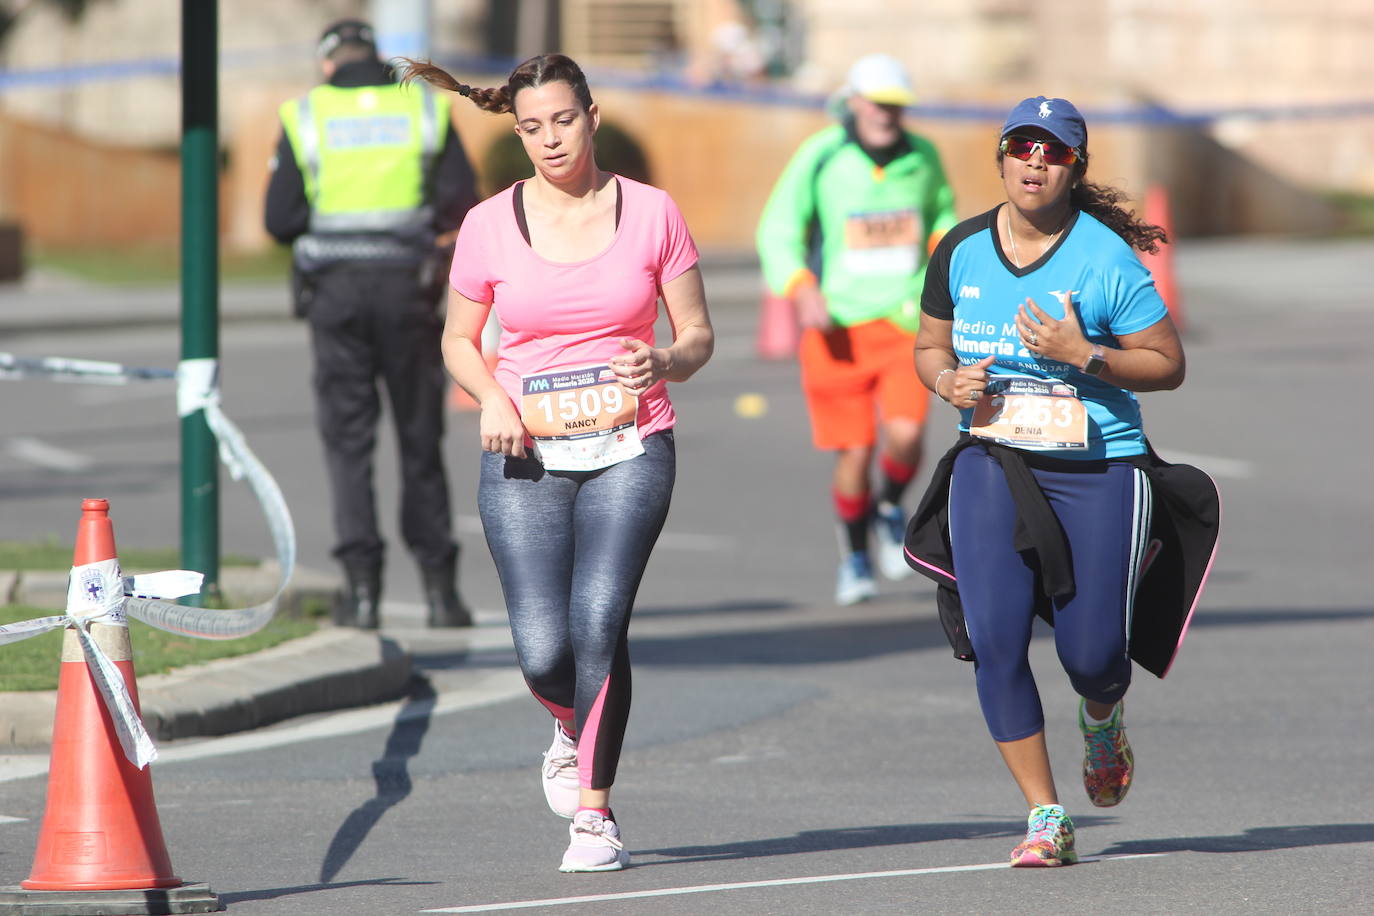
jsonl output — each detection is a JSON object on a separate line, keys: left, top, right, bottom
{"left": 477, "top": 430, "right": 677, "bottom": 788}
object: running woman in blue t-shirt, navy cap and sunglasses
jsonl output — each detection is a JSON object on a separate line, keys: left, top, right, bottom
{"left": 916, "top": 96, "right": 1184, "bottom": 865}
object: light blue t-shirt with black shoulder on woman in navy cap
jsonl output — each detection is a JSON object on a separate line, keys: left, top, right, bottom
{"left": 921, "top": 205, "right": 1168, "bottom": 459}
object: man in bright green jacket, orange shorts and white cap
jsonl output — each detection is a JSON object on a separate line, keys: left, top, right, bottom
{"left": 757, "top": 55, "right": 958, "bottom": 604}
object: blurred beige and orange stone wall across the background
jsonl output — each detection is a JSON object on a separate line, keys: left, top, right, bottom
{"left": 0, "top": 0, "right": 1374, "bottom": 249}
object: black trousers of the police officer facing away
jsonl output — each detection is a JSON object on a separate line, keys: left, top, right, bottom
{"left": 306, "top": 265, "right": 456, "bottom": 571}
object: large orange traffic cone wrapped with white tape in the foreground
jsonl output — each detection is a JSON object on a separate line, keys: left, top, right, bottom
{"left": 10, "top": 500, "right": 218, "bottom": 913}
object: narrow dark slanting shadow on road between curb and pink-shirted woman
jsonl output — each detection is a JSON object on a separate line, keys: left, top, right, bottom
{"left": 320, "top": 678, "right": 437, "bottom": 883}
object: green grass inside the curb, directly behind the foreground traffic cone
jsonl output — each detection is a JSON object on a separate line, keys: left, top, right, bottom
{"left": 0, "top": 602, "right": 327, "bottom": 691}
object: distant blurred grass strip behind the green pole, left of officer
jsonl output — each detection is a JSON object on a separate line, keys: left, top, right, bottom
{"left": 25, "top": 246, "right": 291, "bottom": 286}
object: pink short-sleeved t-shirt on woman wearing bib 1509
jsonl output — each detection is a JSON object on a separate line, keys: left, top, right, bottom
{"left": 449, "top": 176, "right": 698, "bottom": 435}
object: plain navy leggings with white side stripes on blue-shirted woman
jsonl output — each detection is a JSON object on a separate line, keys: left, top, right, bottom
{"left": 949, "top": 445, "right": 1150, "bottom": 742}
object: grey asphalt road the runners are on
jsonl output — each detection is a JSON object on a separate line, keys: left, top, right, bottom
{"left": 0, "top": 240, "right": 1374, "bottom": 916}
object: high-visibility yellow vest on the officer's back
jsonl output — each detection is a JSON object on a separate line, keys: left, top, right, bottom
{"left": 280, "top": 85, "right": 449, "bottom": 235}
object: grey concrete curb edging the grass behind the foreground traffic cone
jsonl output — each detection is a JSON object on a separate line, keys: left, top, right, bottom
{"left": 0, "top": 628, "right": 412, "bottom": 747}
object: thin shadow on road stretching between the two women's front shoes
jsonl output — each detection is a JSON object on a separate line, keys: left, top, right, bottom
{"left": 635, "top": 821, "right": 1026, "bottom": 868}
